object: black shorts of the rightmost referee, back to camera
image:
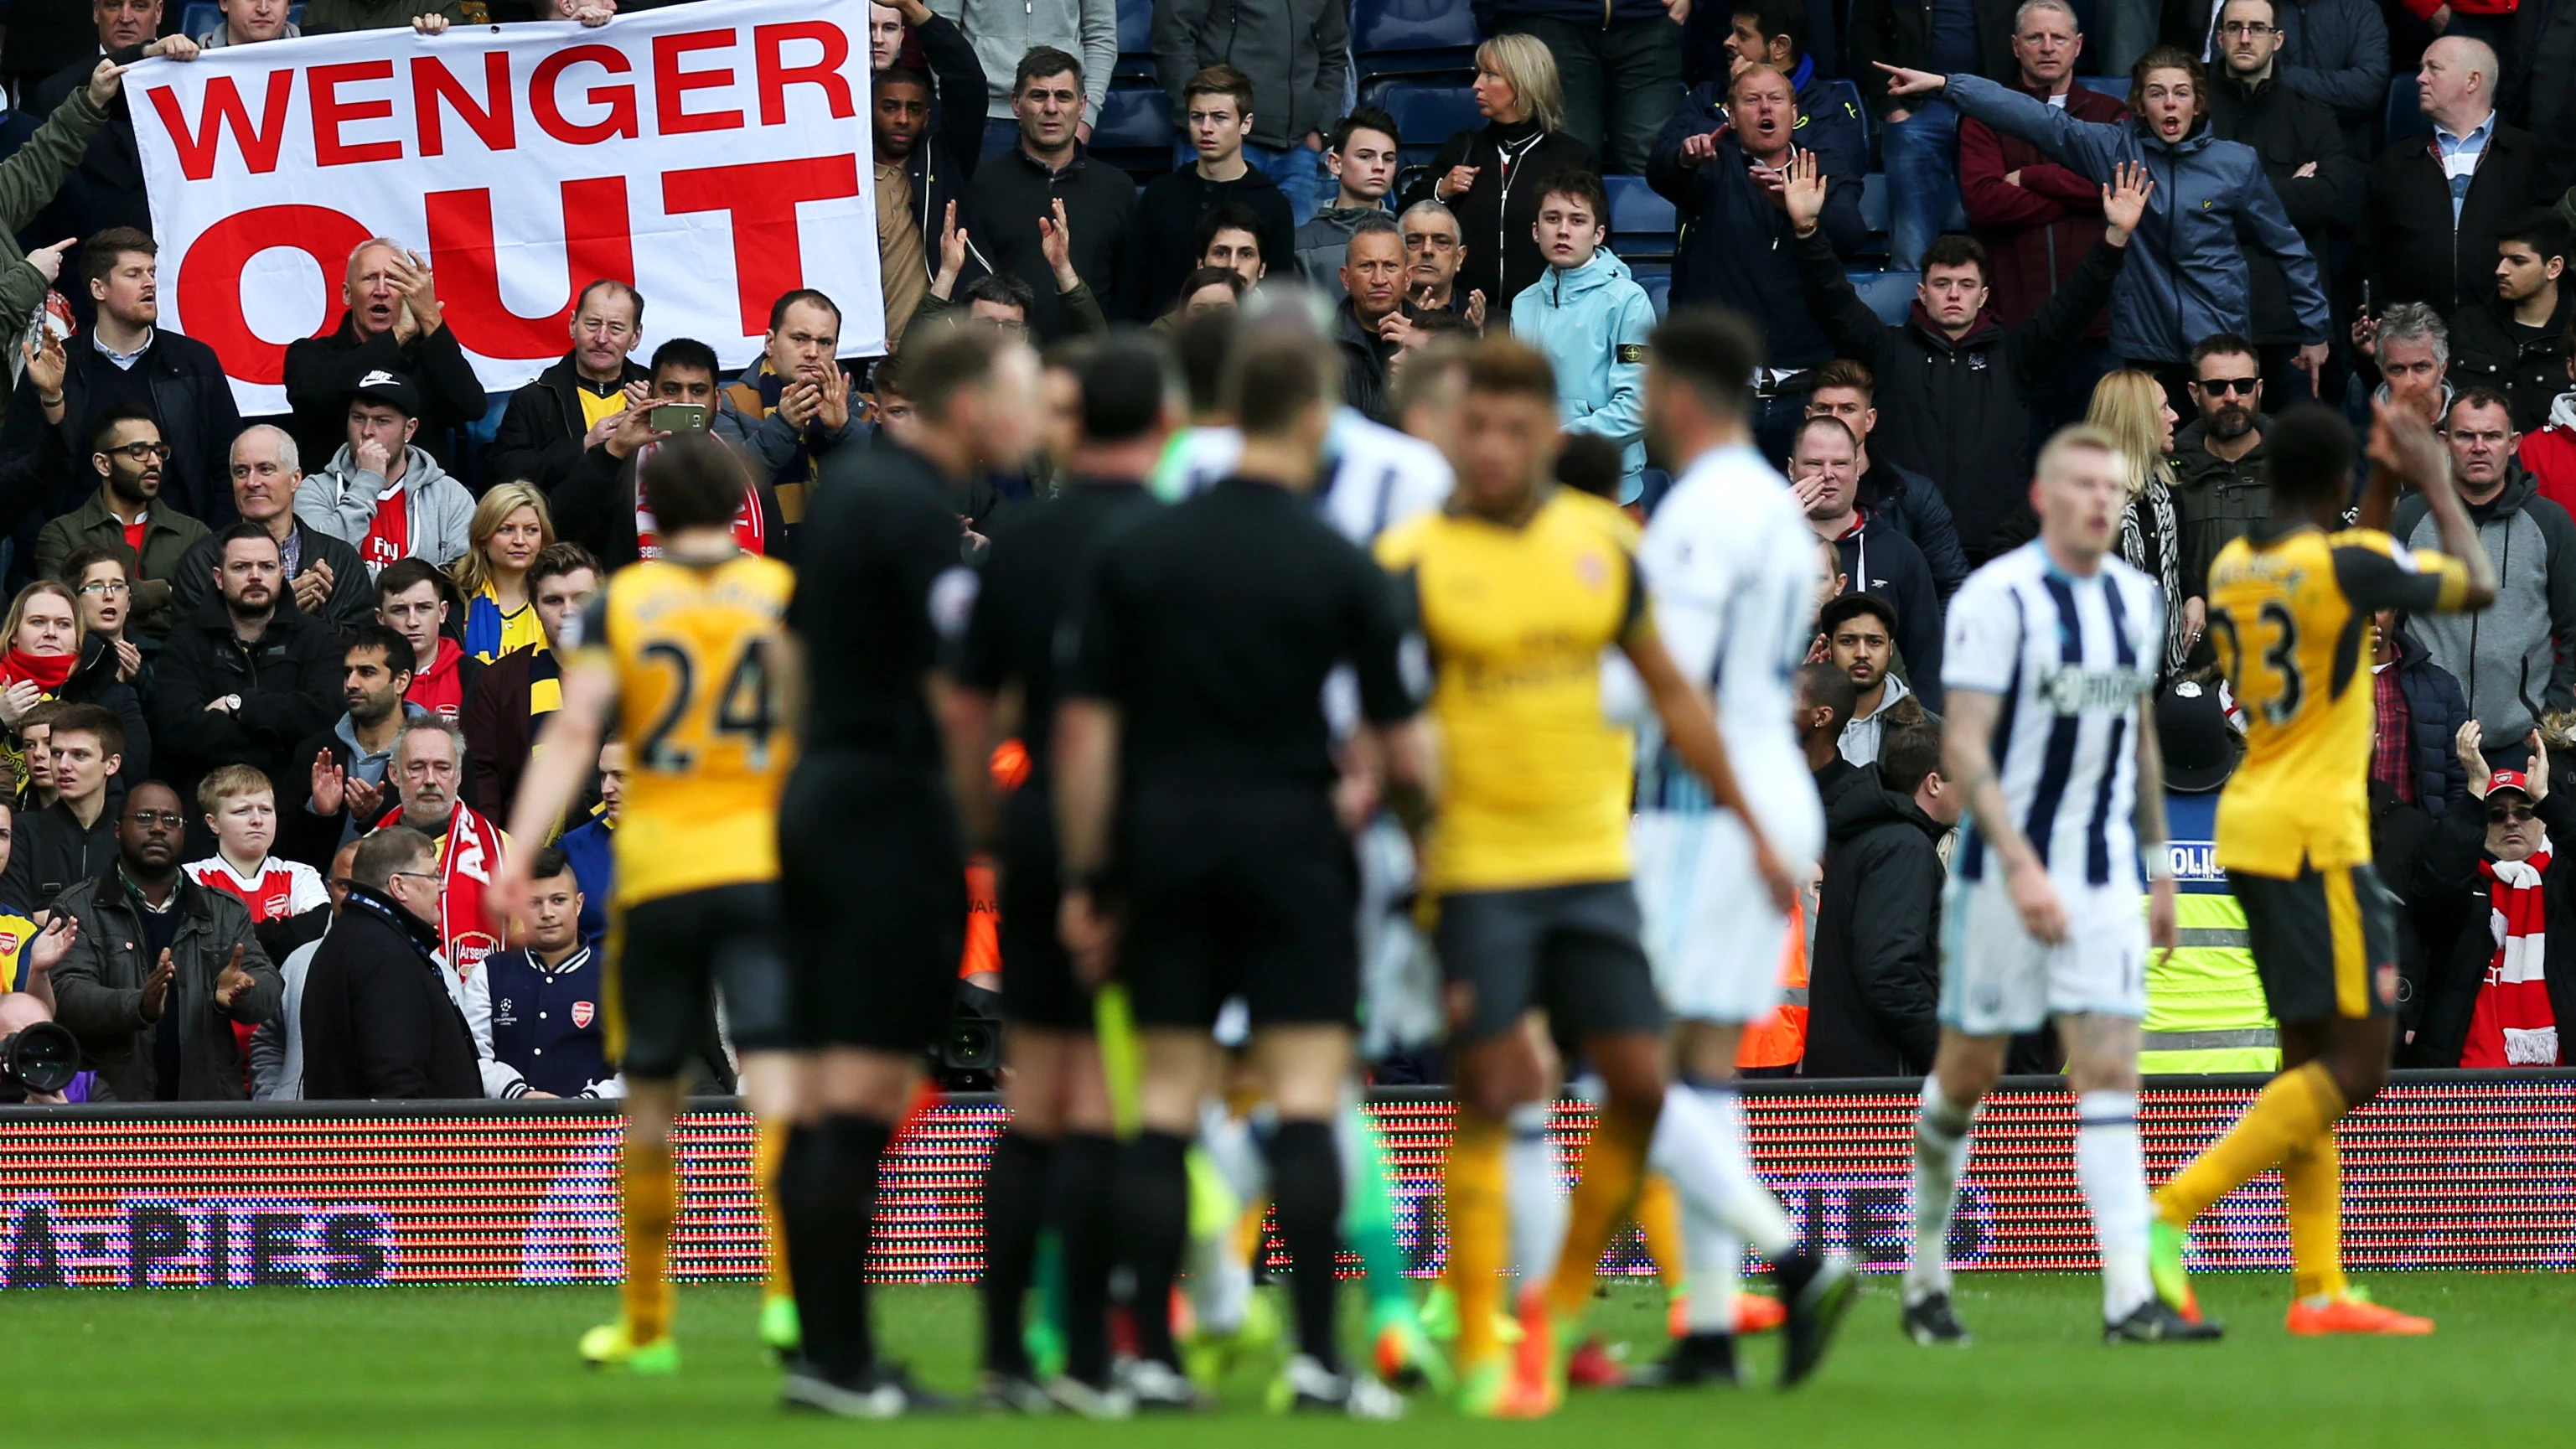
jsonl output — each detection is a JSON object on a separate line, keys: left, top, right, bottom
{"left": 1118, "top": 784, "right": 1360, "bottom": 1029}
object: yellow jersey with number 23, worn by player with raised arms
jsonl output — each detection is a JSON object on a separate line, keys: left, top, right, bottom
{"left": 2207, "top": 526, "right": 2468, "bottom": 879}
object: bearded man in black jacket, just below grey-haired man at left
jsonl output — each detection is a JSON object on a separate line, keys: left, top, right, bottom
{"left": 152, "top": 524, "right": 340, "bottom": 830}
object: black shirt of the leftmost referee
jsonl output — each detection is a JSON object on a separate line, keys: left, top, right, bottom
{"left": 789, "top": 446, "right": 974, "bottom": 766}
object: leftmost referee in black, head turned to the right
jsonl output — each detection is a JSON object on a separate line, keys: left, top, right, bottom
{"left": 773, "top": 330, "right": 1038, "bottom": 1418}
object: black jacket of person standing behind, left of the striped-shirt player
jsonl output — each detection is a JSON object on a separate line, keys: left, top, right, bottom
{"left": 1803, "top": 774, "right": 1948, "bottom": 1078}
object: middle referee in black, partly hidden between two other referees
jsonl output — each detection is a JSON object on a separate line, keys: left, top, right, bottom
{"left": 945, "top": 340, "right": 1180, "bottom": 1415}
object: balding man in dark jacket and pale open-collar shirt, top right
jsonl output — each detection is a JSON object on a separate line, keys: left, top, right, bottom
{"left": 2362, "top": 36, "right": 2555, "bottom": 319}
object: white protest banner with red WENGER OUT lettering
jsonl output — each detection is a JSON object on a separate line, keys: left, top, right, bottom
{"left": 127, "top": 0, "right": 886, "bottom": 415}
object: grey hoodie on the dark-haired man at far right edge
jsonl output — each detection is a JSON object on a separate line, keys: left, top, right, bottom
{"left": 2388, "top": 462, "right": 2576, "bottom": 732}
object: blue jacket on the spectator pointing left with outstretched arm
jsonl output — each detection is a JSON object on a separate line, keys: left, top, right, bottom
{"left": 1950, "top": 75, "right": 2326, "bottom": 364}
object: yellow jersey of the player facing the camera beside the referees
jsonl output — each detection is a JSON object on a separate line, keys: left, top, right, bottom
{"left": 1379, "top": 487, "right": 1646, "bottom": 892}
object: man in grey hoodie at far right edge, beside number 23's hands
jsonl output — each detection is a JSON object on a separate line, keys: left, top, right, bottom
{"left": 2388, "top": 386, "right": 2576, "bottom": 743}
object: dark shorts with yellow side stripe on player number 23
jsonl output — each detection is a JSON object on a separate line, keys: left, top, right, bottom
{"left": 2228, "top": 862, "right": 2398, "bottom": 1021}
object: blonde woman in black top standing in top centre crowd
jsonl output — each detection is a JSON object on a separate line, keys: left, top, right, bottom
{"left": 1404, "top": 34, "right": 1607, "bottom": 317}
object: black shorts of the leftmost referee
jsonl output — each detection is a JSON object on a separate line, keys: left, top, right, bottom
{"left": 778, "top": 755, "right": 966, "bottom": 1054}
